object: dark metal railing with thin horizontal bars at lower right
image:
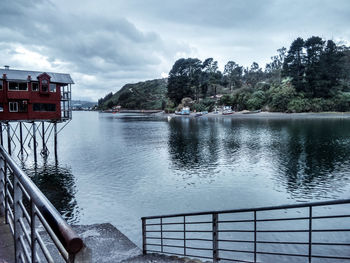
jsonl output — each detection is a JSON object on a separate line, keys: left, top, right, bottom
{"left": 141, "top": 199, "right": 350, "bottom": 263}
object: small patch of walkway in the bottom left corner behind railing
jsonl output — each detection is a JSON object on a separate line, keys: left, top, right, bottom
{"left": 0, "top": 217, "right": 15, "bottom": 263}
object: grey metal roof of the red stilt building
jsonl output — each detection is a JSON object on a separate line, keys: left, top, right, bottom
{"left": 0, "top": 69, "right": 74, "bottom": 84}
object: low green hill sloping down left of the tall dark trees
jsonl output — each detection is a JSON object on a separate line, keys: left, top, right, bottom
{"left": 98, "top": 79, "right": 167, "bottom": 110}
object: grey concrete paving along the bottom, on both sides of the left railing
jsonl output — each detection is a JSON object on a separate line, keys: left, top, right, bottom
{"left": 0, "top": 221, "right": 205, "bottom": 263}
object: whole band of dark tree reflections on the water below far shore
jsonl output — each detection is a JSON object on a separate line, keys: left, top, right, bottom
{"left": 168, "top": 118, "right": 350, "bottom": 199}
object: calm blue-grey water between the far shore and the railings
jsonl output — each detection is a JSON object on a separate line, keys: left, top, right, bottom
{"left": 20, "top": 112, "right": 350, "bottom": 248}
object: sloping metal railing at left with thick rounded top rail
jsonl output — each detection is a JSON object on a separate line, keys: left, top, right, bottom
{"left": 0, "top": 146, "right": 84, "bottom": 262}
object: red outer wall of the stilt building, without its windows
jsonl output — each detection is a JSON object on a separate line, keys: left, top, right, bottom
{"left": 0, "top": 77, "right": 61, "bottom": 121}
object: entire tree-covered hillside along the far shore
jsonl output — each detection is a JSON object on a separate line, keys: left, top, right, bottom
{"left": 99, "top": 36, "right": 350, "bottom": 112}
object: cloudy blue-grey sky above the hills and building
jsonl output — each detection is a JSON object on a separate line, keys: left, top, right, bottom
{"left": 0, "top": 0, "right": 350, "bottom": 101}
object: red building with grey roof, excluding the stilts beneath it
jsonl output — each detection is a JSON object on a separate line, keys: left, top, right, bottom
{"left": 0, "top": 66, "right": 74, "bottom": 122}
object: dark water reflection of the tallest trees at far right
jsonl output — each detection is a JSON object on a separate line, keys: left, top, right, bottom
{"left": 276, "top": 120, "right": 350, "bottom": 199}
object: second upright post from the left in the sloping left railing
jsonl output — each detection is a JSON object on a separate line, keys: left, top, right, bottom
{"left": 13, "top": 174, "right": 23, "bottom": 263}
